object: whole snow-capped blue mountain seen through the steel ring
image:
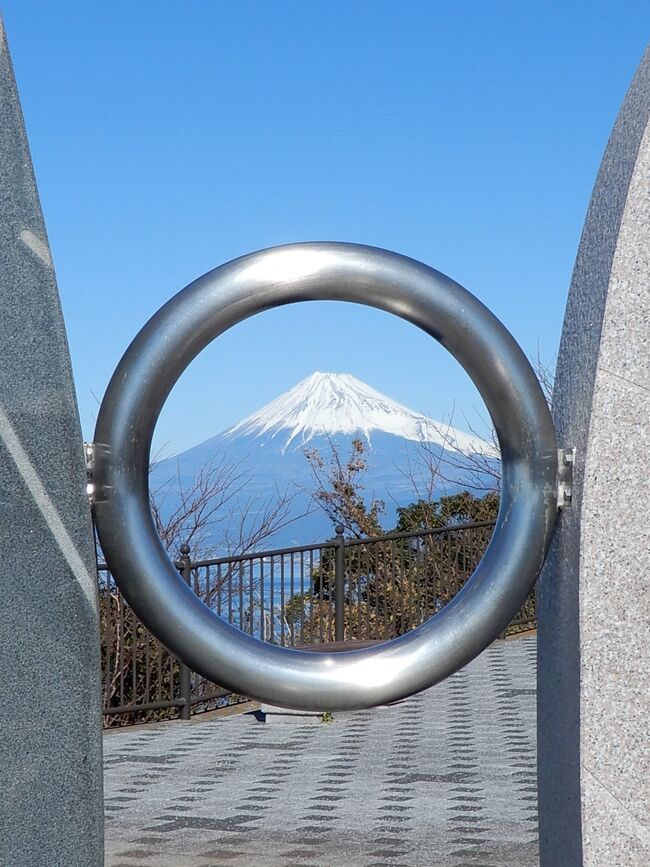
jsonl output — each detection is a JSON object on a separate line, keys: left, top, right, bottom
{"left": 152, "top": 372, "right": 496, "bottom": 549}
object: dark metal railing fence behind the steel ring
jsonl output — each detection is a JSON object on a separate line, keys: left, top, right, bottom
{"left": 99, "top": 521, "right": 535, "bottom": 725}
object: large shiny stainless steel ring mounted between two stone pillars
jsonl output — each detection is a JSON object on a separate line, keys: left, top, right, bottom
{"left": 94, "top": 243, "right": 557, "bottom": 710}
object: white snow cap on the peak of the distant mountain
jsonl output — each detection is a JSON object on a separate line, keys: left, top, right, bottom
{"left": 224, "top": 371, "right": 488, "bottom": 454}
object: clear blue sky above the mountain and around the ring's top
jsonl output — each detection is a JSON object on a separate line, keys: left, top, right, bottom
{"left": 2, "top": 0, "right": 650, "bottom": 454}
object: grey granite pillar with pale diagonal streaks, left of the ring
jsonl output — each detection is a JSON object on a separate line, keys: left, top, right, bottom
{"left": 0, "top": 22, "right": 103, "bottom": 867}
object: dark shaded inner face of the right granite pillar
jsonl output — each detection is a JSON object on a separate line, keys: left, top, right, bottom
{"left": 537, "top": 49, "right": 650, "bottom": 867}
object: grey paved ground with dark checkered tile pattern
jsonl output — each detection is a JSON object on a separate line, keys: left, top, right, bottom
{"left": 104, "top": 637, "right": 538, "bottom": 867}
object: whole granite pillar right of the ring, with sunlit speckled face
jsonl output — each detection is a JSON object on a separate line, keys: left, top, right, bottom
{"left": 538, "top": 50, "right": 650, "bottom": 867}
